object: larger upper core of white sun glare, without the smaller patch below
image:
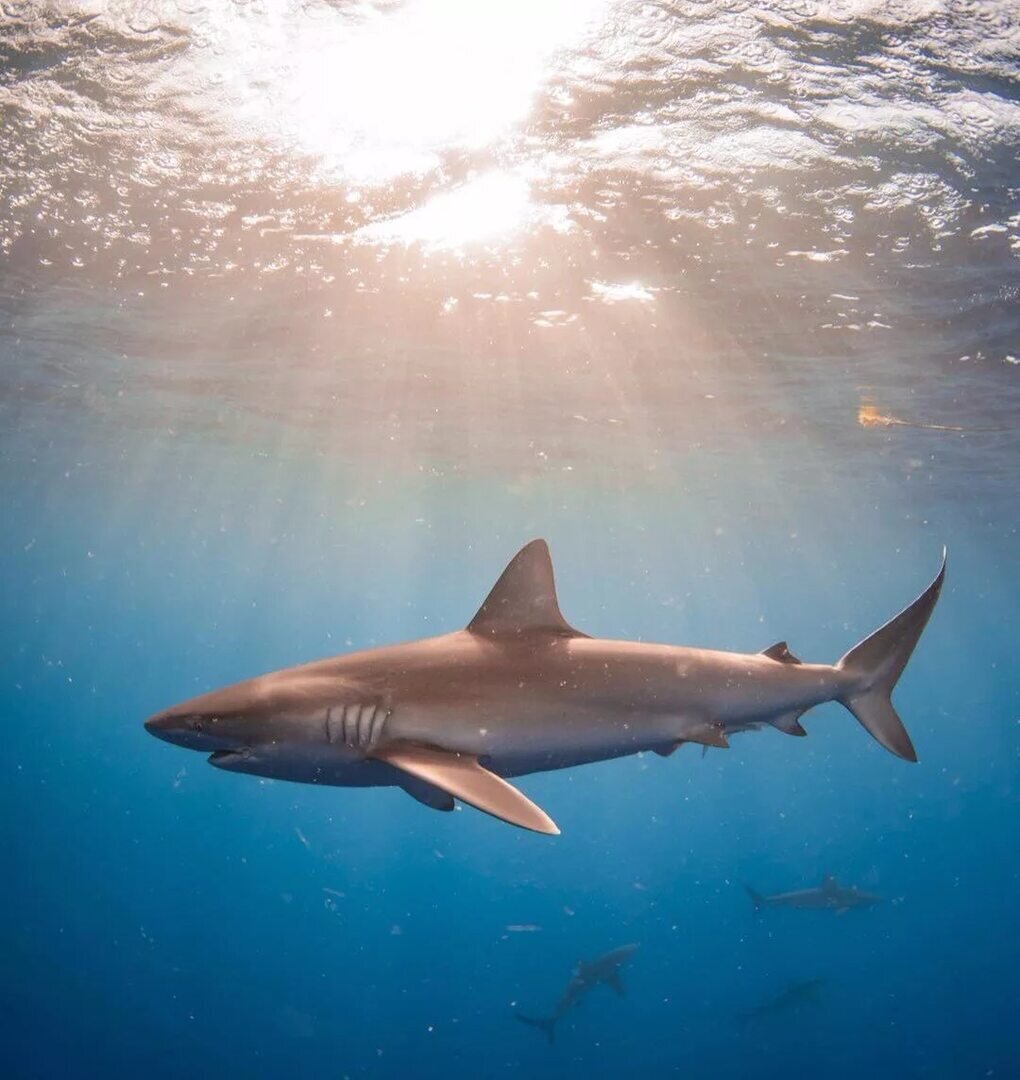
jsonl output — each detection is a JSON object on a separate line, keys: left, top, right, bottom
{"left": 276, "top": 0, "right": 602, "bottom": 184}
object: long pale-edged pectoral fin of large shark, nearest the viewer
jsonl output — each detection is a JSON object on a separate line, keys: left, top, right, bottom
{"left": 370, "top": 743, "right": 560, "bottom": 836}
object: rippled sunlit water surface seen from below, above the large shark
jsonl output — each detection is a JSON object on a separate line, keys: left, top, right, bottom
{"left": 0, "top": 0, "right": 1020, "bottom": 490}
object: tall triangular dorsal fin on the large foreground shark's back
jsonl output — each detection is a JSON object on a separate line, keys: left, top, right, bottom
{"left": 468, "top": 540, "right": 588, "bottom": 637}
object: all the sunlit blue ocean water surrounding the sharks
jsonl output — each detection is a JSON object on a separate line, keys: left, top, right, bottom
{"left": 0, "top": 0, "right": 1020, "bottom": 1080}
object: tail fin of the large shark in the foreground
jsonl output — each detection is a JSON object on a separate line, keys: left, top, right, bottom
{"left": 836, "top": 549, "right": 945, "bottom": 761}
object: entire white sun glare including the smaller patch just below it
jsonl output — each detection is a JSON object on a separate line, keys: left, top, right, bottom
{"left": 186, "top": 0, "right": 608, "bottom": 247}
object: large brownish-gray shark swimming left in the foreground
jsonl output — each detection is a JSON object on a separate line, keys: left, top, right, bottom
{"left": 145, "top": 540, "right": 945, "bottom": 833}
